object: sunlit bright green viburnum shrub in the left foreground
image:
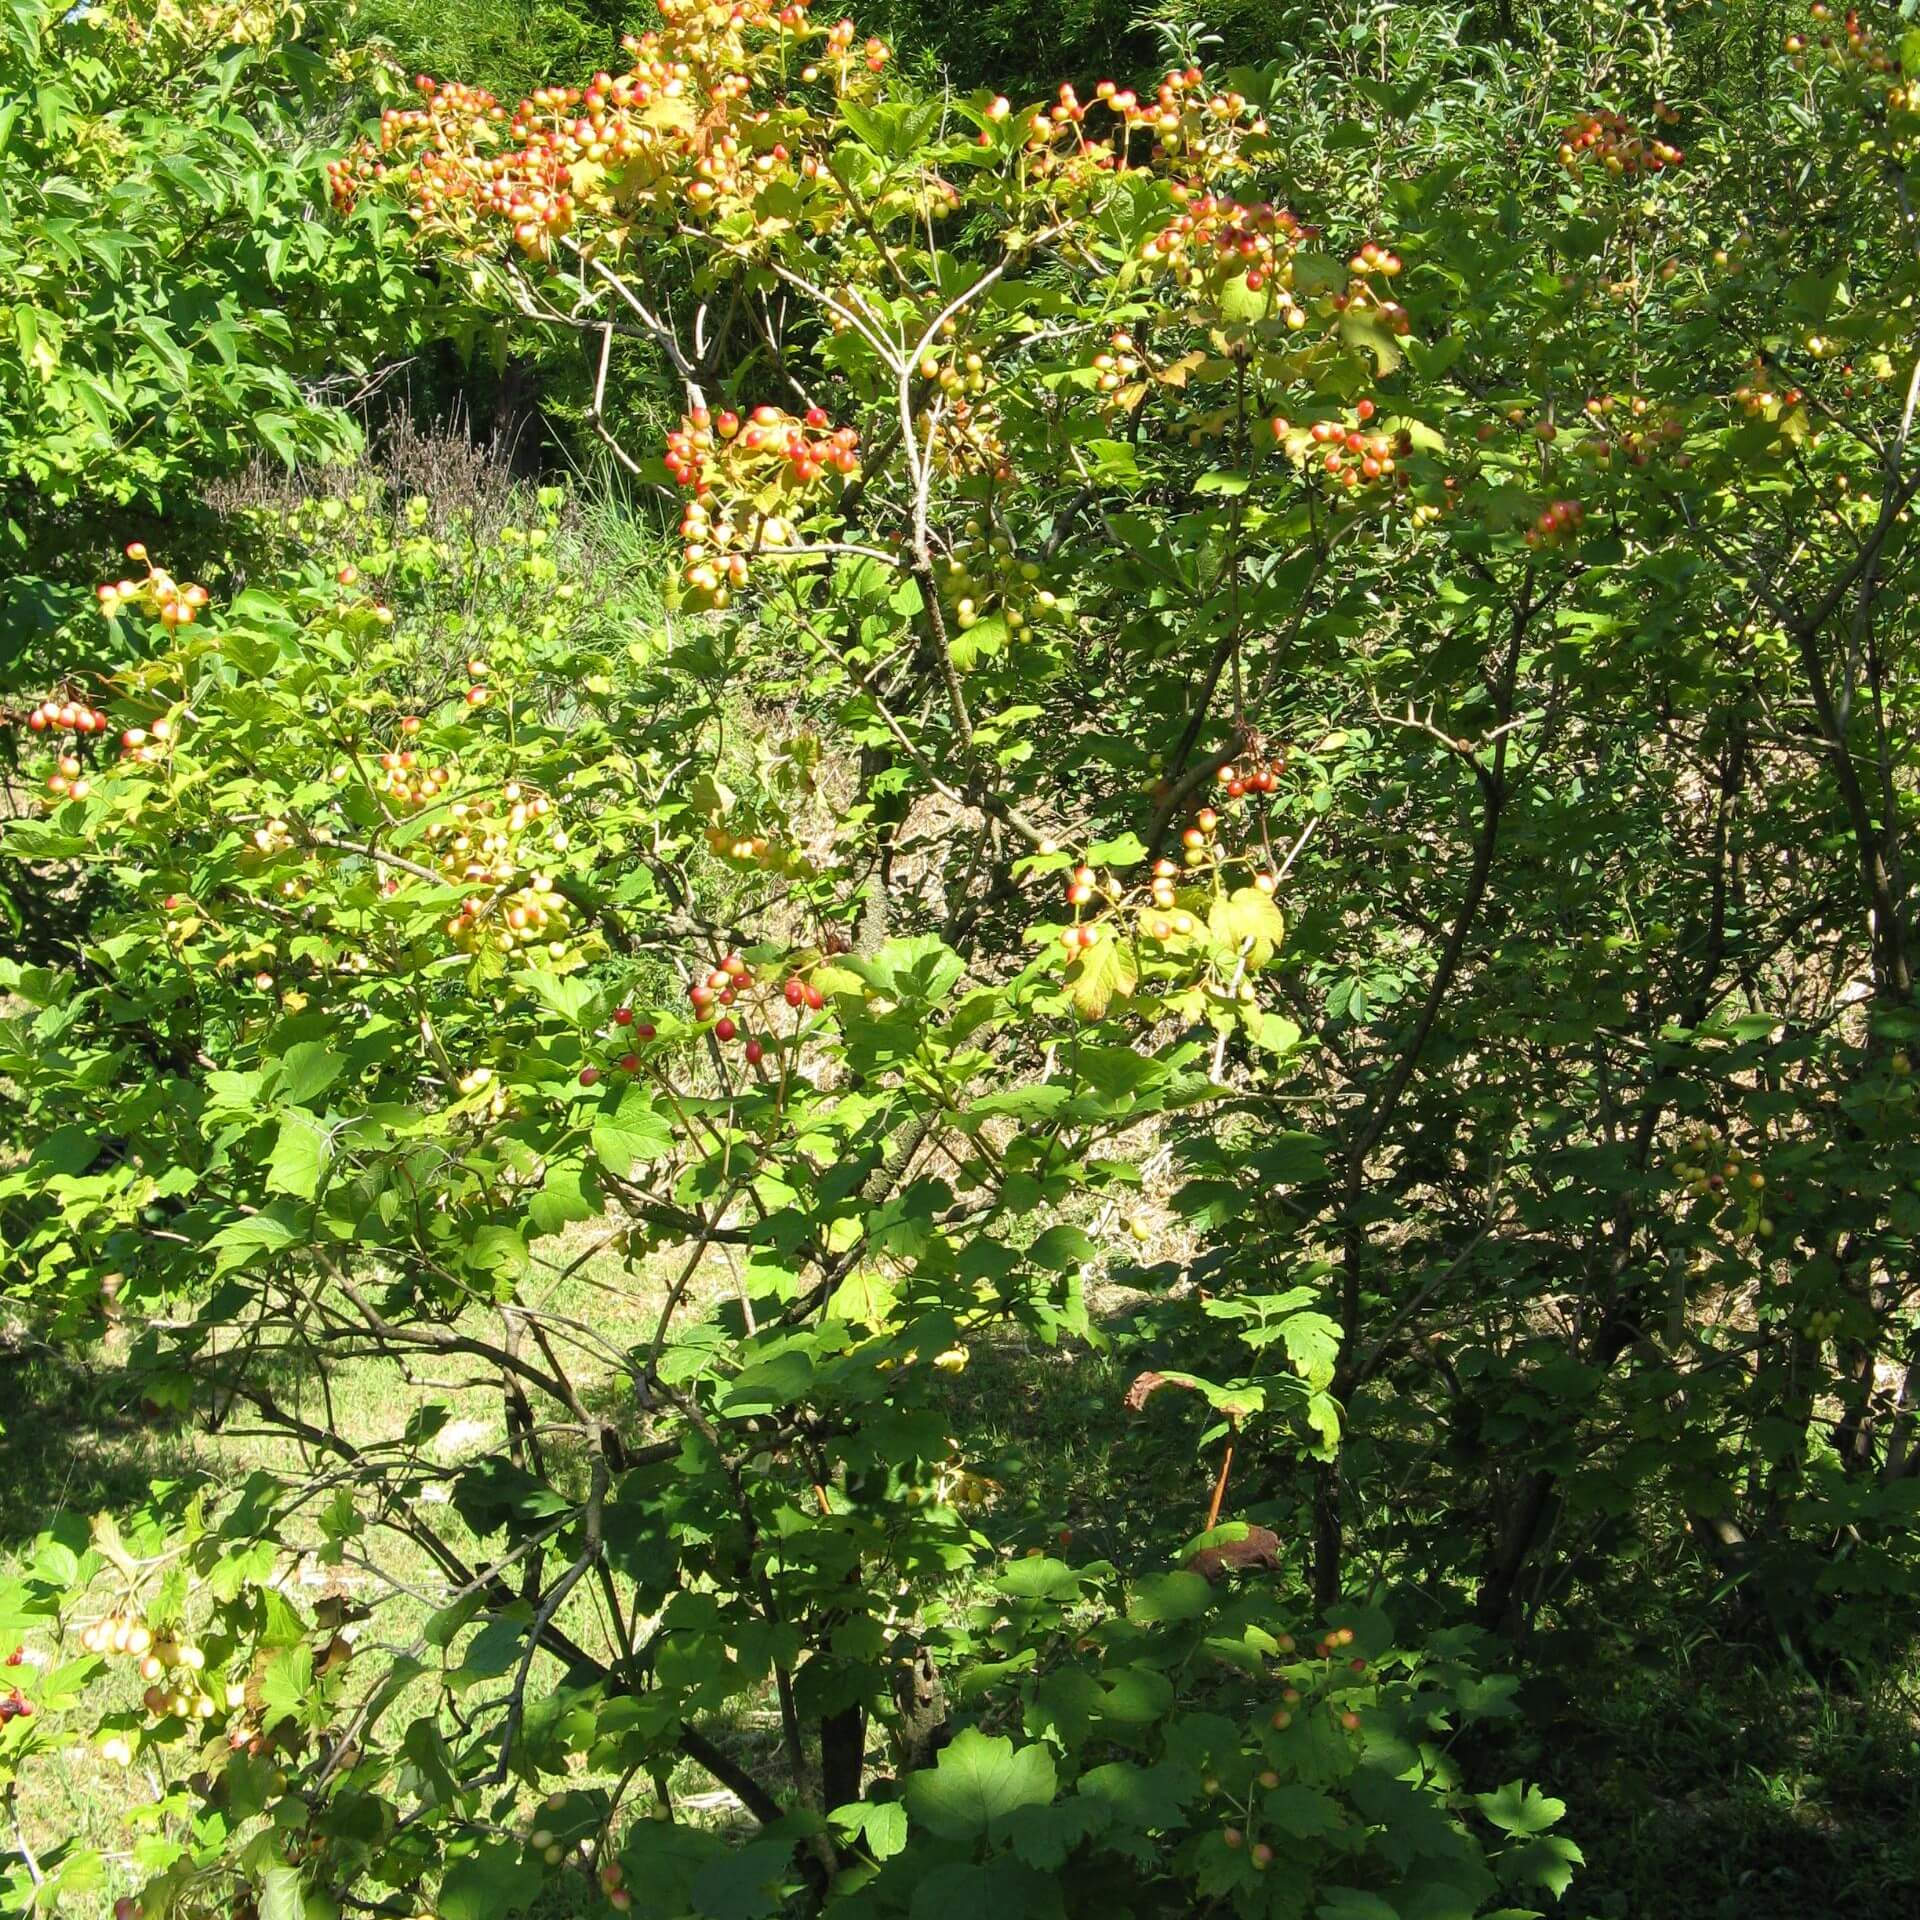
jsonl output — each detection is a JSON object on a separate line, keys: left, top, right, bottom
{"left": 0, "top": 464, "right": 1571, "bottom": 1916}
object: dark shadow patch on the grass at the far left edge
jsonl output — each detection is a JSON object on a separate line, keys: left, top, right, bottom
{"left": 0, "top": 1354, "right": 198, "bottom": 1551}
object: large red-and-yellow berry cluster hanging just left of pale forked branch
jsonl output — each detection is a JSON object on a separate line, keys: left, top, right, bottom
{"left": 666, "top": 407, "right": 860, "bottom": 607}
